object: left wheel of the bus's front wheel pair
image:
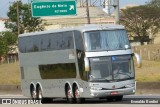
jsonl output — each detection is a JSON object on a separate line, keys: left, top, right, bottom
{"left": 66, "top": 85, "right": 74, "bottom": 103}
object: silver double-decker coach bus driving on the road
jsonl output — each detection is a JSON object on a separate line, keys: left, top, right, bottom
{"left": 18, "top": 24, "right": 141, "bottom": 103}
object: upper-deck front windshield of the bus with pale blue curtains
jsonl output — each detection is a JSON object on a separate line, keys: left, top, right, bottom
{"left": 84, "top": 30, "right": 130, "bottom": 51}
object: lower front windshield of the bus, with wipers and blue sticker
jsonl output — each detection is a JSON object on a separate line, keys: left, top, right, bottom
{"left": 90, "top": 55, "right": 134, "bottom": 82}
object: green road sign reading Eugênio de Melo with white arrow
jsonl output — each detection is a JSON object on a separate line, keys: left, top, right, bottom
{"left": 31, "top": 0, "right": 76, "bottom": 17}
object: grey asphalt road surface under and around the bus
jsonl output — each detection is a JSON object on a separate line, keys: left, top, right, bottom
{"left": 0, "top": 95, "right": 160, "bottom": 107}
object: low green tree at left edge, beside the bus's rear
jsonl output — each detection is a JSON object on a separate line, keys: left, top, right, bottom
{"left": 0, "top": 31, "right": 17, "bottom": 56}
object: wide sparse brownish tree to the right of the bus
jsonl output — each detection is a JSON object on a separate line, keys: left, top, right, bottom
{"left": 120, "top": 5, "right": 160, "bottom": 45}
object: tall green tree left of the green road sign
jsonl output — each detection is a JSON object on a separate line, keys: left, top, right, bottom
{"left": 5, "top": 1, "right": 44, "bottom": 34}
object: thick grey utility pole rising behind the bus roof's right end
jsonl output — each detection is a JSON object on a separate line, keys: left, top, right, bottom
{"left": 113, "top": 0, "right": 119, "bottom": 24}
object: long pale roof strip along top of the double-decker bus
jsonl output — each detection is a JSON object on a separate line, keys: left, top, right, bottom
{"left": 19, "top": 24, "right": 124, "bottom": 37}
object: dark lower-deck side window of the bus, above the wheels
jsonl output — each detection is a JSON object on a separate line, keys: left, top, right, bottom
{"left": 39, "top": 63, "right": 76, "bottom": 79}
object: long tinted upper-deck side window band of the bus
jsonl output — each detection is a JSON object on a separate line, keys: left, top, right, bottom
{"left": 19, "top": 32, "right": 74, "bottom": 53}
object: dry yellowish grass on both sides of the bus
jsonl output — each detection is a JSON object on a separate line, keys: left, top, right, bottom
{"left": 0, "top": 60, "right": 160, "bottom": 85}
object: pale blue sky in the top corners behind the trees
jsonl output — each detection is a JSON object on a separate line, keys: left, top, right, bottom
{"left": 0, "top": 0, "right": 150, "bottom": 18}
